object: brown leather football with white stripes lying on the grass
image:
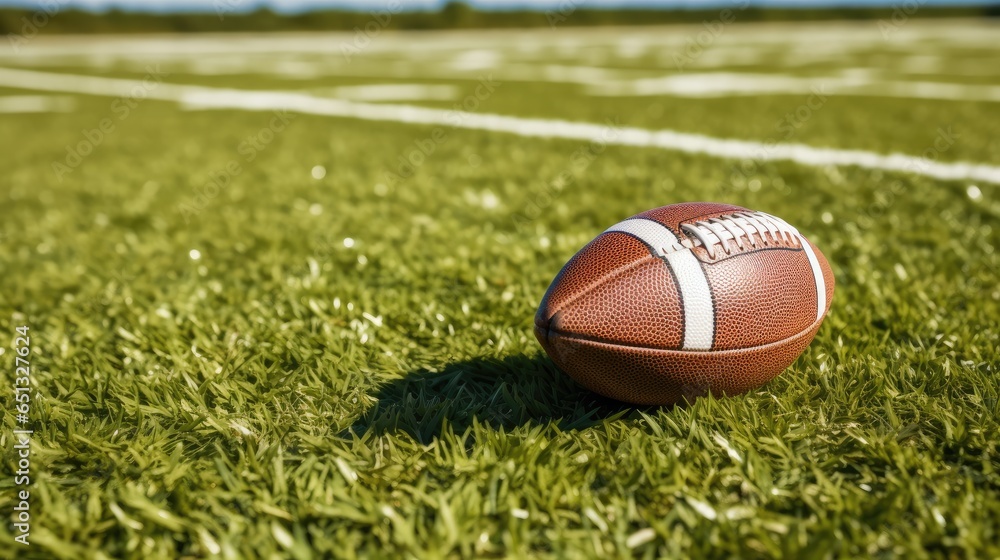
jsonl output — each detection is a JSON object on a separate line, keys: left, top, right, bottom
{"left": 535, "top": 202, "right": 834, "bottom": 404}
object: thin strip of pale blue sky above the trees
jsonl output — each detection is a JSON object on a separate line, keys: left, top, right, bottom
{"left": 0, "top": 0, "right": 991, "bottom": 12}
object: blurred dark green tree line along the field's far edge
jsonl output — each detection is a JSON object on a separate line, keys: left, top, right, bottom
{"left": 0, "top": 0, "right": 1000, "bottom": 36}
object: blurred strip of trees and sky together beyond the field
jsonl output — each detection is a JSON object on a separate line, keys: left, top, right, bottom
{"left": 0, "top": 0, "right": 998, "bottom": 33}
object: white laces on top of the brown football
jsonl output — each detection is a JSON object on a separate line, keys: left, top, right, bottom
{"left": 681, "top": 212, "right": 801, "bottom": 259}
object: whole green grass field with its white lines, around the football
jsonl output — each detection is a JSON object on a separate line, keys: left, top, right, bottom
{"left": 0, "top": 21, "right": 1000, "bottom": 559}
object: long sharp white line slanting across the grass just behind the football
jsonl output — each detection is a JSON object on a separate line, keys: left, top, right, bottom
{"left": 0, "top": 68, "right": 1000, "bottom": 184}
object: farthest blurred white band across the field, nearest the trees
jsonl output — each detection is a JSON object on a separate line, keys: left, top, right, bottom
{"left": 0, "top": 21, "right": 1000, "bottom": 60}
